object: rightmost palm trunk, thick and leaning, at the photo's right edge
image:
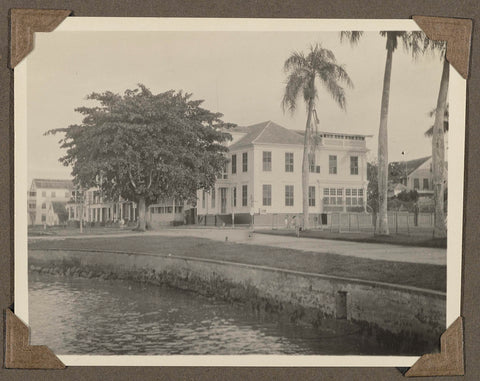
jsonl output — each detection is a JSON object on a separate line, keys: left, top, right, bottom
{"left": 432, "top": 58, "right": 450, "bottom": 238}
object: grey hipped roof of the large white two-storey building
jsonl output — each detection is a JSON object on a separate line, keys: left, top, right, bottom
{"left": 229, "top": 120, "right": 303, "bottom": 150}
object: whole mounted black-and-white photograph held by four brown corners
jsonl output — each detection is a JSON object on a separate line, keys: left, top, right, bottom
{"left": 15, "top": 19, "right": 465, "bottom": 366}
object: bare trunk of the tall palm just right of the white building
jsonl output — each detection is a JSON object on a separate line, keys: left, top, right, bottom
{"left": 376, "top": 37, "right": 393, "bottom": 235}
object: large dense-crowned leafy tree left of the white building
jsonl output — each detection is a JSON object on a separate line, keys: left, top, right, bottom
{"left": 47, "top": 85, "right": 231, "bottom": 230}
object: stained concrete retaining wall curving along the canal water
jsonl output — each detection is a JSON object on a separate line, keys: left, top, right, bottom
{"left": 29, "top": 250, "right": 446, "bottom": 348}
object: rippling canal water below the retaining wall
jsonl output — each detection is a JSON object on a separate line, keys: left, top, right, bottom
{"left": 29, "top": 273, "right": 385, "bottom": 355}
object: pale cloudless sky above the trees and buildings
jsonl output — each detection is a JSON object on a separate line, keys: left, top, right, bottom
{"left": 27, "top": 31, "right": 442, "bottom": 182}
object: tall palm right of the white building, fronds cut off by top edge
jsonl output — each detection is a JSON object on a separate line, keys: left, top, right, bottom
{"left": 340, "top": 31, "right": 423, "bottom": 235}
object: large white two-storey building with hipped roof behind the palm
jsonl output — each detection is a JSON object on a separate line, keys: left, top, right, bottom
{"left": 197, "top": 121, "right": 368, "bottom": 225}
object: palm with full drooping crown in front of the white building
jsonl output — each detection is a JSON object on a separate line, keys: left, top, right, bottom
{"left": 282, "top": 43, "right": 353, "bottom": 229}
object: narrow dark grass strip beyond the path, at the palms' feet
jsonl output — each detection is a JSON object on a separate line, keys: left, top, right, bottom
{"left": 255, "top": 229, "right": 447, "bottom": 249}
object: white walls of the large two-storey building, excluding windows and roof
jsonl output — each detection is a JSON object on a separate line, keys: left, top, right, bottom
{"left": 197, "top": 139, "right": 368, "bottom": 215}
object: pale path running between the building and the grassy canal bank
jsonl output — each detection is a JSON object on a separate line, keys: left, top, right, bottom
{"left": 32, "top": 228, "right": 447, "bottom": 265}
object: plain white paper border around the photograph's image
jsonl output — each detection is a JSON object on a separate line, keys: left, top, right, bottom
{"left": 14, "top": 17, "right": 467, "bottom": 367}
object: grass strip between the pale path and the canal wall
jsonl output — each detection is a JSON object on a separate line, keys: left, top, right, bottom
{"left": 29, "top": 235, "right": 446, "bottom": 291}
